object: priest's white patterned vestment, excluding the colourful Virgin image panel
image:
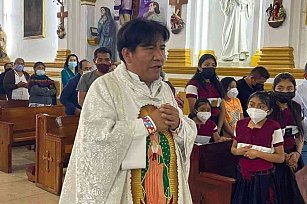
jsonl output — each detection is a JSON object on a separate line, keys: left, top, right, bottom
{"left": 60, "top": 63, "right": 197, "bottom": 204}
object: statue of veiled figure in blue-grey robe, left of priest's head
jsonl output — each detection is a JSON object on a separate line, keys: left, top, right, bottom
{"left": 96, "top": 7, "right": 116, "bottom": 60}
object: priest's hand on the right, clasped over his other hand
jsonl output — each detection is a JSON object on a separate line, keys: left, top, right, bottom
{"left": 159, "top": 104, "right": 180, "bottom": 130}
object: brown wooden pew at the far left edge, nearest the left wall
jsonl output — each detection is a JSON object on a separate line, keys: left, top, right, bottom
{"left": 0, "top": 105, "right": 64, "bottom": 173}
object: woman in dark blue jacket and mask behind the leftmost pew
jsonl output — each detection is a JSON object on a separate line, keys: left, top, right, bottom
{"left": 28, "top": 62, "right": 56, "bottom": 107}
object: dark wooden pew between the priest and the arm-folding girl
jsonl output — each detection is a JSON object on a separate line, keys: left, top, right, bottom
{"left": 189, "top": 141, "right": 238, "bottom": 204}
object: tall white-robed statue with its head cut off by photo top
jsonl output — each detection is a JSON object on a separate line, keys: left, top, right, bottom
{"left": 220, "top": 0, "right": 254, "bottom": 61}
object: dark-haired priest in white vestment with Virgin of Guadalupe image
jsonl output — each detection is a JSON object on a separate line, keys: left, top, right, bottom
{"left": 60, "top": 19, "right": 196, "bottom": 204}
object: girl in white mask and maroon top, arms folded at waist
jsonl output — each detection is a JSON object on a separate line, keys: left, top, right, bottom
{"left": 231, "top": 92, "right": 285, "bottom": 204}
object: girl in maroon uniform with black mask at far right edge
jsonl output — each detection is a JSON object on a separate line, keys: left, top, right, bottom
{"left": 270, "top": 73, "right": 304, "bottom": 204}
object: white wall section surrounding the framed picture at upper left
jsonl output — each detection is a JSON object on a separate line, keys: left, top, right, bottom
{"left": 1, "top": 0, "right": 59, "bottom": 62}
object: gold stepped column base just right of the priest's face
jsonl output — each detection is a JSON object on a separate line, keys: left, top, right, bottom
{"left": 165, "top": 49, "right": 192, "bottom": 66}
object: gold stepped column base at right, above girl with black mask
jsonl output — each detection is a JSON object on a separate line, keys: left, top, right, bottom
{"left": 258, "top": 47, "right": 295, "bottom": 68}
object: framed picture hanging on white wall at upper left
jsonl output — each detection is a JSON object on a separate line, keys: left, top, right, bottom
{"left": 23, "top": 0, "right": 45, "bottom": 38}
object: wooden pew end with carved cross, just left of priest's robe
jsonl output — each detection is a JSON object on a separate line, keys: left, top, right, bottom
{"left": 35, "top": 114, "right": 79, "bottom": 195}
